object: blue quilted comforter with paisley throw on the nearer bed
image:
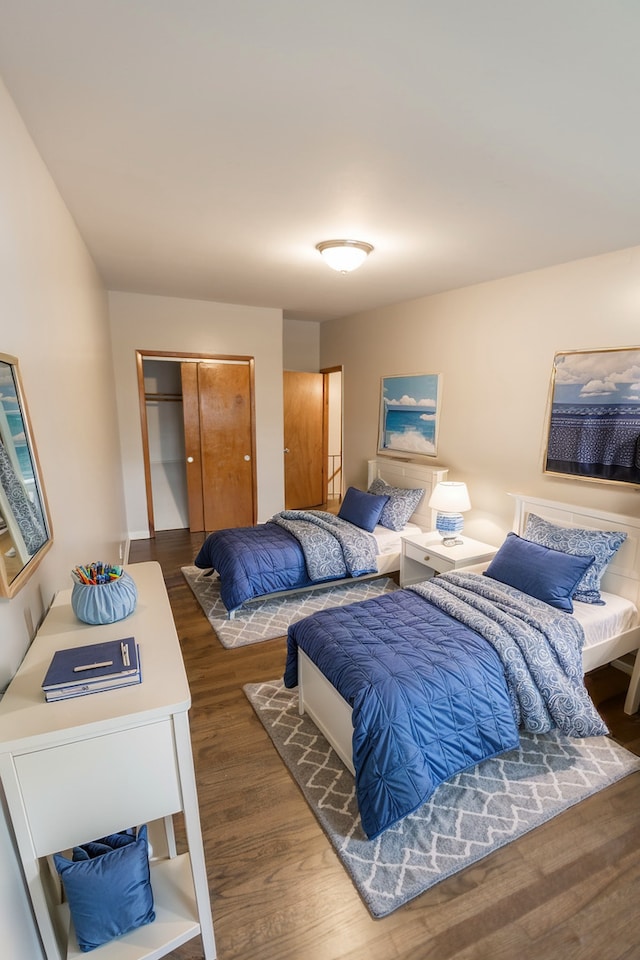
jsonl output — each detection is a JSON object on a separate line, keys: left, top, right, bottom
{"left": 284, "top": 573, "right": 607, "bottom": 839}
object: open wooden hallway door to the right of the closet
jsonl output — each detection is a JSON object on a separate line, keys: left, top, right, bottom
{"left": 284, "top": 370, "right": 327, "bottom": 510}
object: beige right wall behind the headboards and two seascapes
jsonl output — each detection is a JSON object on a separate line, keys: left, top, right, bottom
{"left": 321, "top": 247, "right": 640, "bottom": 544}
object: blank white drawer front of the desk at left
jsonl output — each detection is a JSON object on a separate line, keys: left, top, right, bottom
{"left": 15, "top": 720, "right": 182, "bottom": 857}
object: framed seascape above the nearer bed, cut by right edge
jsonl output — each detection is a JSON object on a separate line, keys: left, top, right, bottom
{"left": 544, "top": 347, "right": 640, "bottom": 484}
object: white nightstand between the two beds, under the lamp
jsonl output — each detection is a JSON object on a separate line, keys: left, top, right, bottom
{"left": 400, "top": 531, "right": 498, "bottom": 587}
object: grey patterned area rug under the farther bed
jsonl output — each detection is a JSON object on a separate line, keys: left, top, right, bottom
{"left": 182, "top": 567, "right": 399, "bottom": 647}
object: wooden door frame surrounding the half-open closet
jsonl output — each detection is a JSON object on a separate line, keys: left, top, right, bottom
{"left": 135, "top": 350, "right": 258, "bottom": 538}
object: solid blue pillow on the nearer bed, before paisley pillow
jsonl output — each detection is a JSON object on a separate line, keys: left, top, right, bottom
{"left": 484, "top": 533, "right": 594, "bottom": 613}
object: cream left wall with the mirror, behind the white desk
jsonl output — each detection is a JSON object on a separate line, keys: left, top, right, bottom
{"left": 0, "top": 82, "right": 129, "bottom": 960}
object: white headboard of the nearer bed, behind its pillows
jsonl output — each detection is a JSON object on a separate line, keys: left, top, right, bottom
{"left": 509, "top": 493, "right": 640, "bottom": 608}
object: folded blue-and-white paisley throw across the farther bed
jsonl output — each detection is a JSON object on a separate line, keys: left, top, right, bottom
{"left": 268, "top": 510, "right": 378, "bottom": 582}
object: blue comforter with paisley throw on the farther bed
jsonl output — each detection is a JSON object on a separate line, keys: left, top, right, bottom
{"left": 194, "top": 510, "right": 377, "bottom": 611}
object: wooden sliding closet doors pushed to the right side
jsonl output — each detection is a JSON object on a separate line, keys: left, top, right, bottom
{"left": 182, "top": 361, "right": 255, "bottom": 531}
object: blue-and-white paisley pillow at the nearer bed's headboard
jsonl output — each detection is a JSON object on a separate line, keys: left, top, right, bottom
{"left": 524, "top": 513, "right": 627, "bottom": 604}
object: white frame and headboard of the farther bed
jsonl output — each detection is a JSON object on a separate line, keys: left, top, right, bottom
{"left": 227, "top": 457, "right": 447, "bottom": 620}
